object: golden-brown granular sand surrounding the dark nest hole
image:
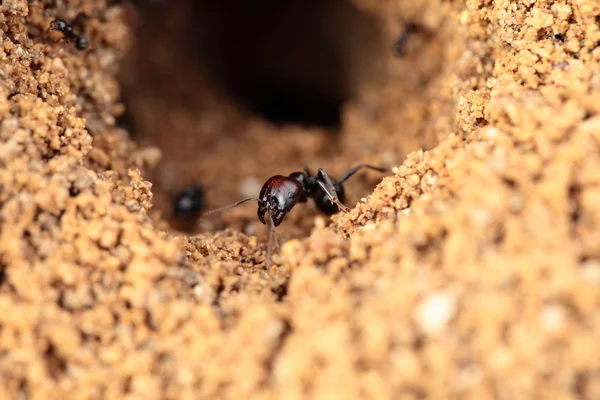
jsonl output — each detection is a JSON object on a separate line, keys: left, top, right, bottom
{"left": 0, "top": 0, "right": 600, "bottom": 399}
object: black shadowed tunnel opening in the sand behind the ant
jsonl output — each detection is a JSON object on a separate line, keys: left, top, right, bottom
{"left": 190, "top": 0, "right": 379, "bottom": 127}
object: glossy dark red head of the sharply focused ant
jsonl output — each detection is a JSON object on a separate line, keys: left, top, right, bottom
{"left": 257, "top": 175, "right": 303, "bottom": 226}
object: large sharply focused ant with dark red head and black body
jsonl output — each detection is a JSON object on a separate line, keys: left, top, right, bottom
{"left": 203, "top": 164, "right": 388, "bottom": 269}
